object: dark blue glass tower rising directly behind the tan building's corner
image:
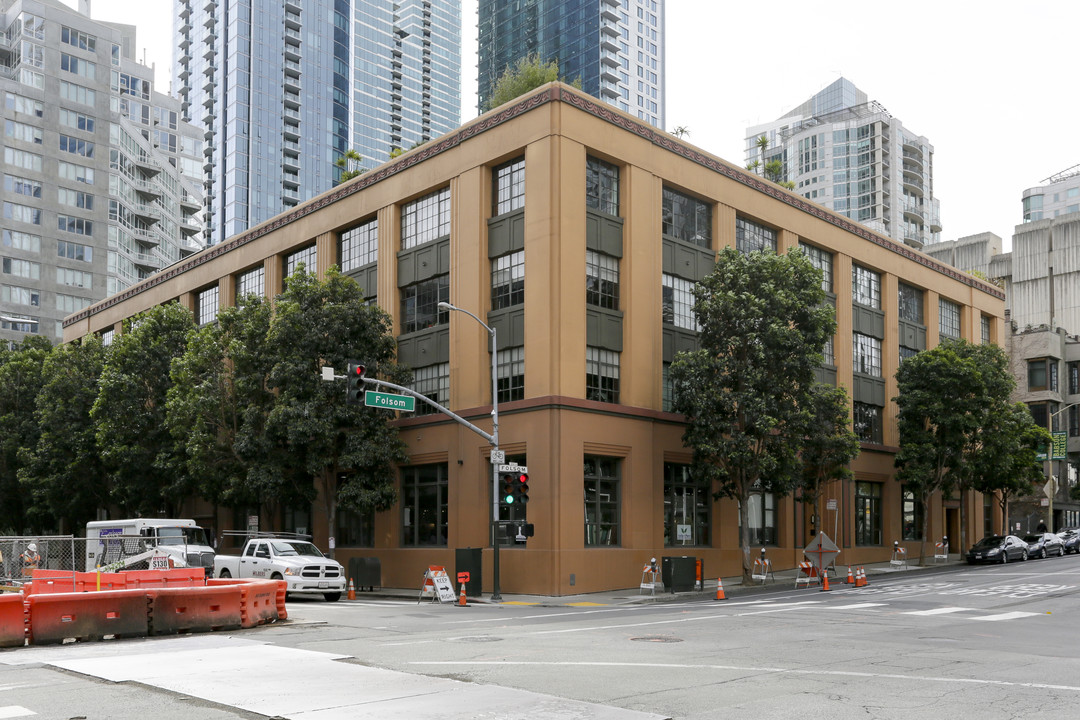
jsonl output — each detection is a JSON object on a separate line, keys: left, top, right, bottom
{"left": 477, "top": 0, "right": 666, "bottom": 127}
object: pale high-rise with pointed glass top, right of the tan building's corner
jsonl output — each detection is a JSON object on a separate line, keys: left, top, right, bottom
{"left": 746, "top": 78, "right": 942, "bottom": 248}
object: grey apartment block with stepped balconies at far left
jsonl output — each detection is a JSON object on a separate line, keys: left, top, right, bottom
{"left": 0, "top": 0, "right": 202, "bottom": 341}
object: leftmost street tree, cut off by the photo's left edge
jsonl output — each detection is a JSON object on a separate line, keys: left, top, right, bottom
{"left": 0, "top": 336, "right": 52, "bottom": 531}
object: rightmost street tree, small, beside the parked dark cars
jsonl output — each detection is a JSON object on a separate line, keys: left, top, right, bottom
{"left": 971, "top": 403, "right": 1050, "bottom": 529}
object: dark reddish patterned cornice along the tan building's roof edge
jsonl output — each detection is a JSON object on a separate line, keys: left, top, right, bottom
{"left": 64, "top": 84, "right": 1005, "bottom": 327}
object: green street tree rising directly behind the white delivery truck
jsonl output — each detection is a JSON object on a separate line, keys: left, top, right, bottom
{"left": 91, "top": 302, "right": 194, "bottom": 515}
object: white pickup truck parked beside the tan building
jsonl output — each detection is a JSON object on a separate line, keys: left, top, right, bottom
{"left": 214, "top": 538, "right": 347, "bottom": 602}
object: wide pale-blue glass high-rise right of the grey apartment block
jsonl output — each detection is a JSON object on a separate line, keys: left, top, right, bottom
{"left": 173, "top": 0, "right": 461, "bottom": 244}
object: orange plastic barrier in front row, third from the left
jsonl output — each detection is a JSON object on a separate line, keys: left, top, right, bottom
{"left": 146, "top": 585, "right": 242, "bottom": 635}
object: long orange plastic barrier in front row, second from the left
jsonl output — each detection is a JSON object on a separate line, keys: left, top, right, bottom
{"left": 26, "top": 590, "right": 147, "bottom": 644}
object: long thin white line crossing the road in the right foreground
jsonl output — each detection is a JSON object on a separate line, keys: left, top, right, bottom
{"left": 408, "top": 660, "right": 1080, "bottom": 693}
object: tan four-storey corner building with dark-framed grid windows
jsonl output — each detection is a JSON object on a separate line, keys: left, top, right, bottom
{"left": 65, "top": 84, "right": 1004, "bottom": 595}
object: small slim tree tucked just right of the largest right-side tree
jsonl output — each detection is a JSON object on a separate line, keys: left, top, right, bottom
{"left": 799, "top": 383, "right": 859, "bottom": 537}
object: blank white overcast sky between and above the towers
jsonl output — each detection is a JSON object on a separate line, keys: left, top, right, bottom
{"left": 63, "top": 0, "right": 1080, "bottom": 250}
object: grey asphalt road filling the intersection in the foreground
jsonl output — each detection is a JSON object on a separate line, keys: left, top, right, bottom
{"left": 0, "top": 556, "right": 1080, "bottom": 720}
